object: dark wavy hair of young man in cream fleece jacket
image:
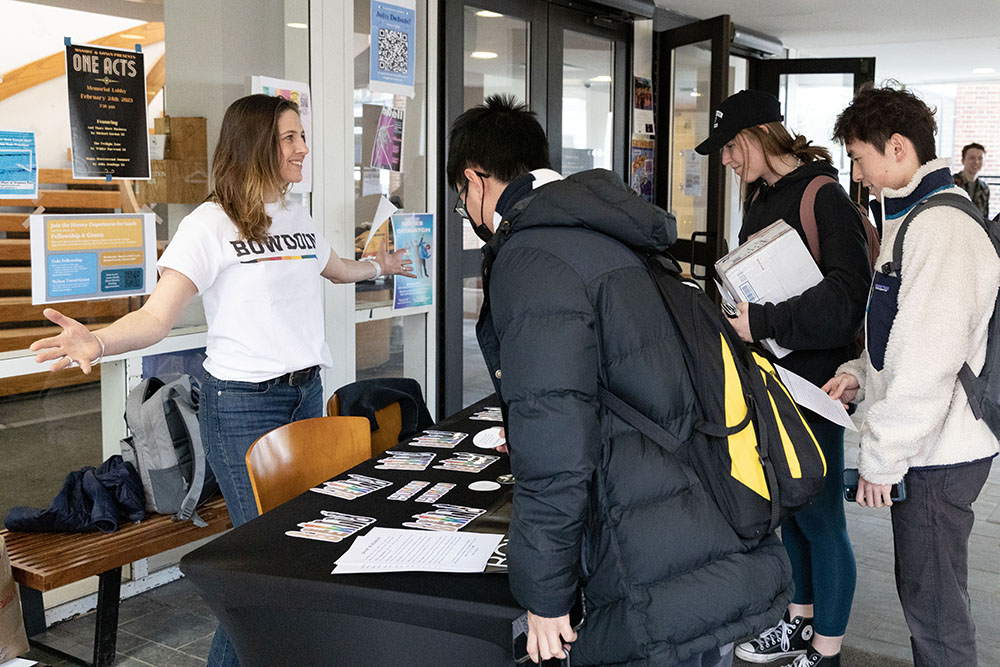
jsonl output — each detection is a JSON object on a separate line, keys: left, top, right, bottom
{"left": 833, "top": 82, "right": 937, "bottom": 164}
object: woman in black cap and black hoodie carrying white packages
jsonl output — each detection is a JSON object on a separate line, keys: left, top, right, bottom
{"left": 695, "top": 90, "right": 871, "bottom": 667}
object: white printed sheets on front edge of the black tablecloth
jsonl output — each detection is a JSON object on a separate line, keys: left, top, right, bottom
{"left": 331, "top": 528, "right": 503, "bottom": 574}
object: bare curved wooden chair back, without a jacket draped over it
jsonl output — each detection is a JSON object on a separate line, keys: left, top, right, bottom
{"left": 246, "top": 417, "right": 371, "bottom": 514}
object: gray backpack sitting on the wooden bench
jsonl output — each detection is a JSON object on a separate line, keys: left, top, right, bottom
{"left": 121, "top": 375, "right": 219, "bottom": 526}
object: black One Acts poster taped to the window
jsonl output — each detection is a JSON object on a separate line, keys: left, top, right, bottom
{"left": 66, "top": 44, "right": 149, "bottom": 179}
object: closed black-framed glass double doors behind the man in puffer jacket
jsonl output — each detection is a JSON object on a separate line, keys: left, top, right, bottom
{"left": 438, "top": 0, "right": 632, "bottom": 414}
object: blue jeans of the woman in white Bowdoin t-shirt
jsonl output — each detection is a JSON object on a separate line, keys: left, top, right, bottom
{"left": 199, "top": 373, "right": 323, "bottom": 667}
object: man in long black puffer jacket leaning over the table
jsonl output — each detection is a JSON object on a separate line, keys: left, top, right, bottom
{"left": 448, "top": 97, "right": 791, "bottom": 667}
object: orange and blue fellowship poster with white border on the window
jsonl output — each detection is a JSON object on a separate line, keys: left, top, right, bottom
{"left": 30, "top": 213, "right": 156, "bottom": 305}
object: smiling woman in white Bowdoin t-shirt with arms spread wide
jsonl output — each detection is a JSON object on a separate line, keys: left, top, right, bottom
{"left": 31, "top": 95, "right": 415, "bottom": 665}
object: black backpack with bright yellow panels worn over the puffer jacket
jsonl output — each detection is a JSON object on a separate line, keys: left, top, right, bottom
{"left": 600, "top": 253, "right": 826, "bottom": 542}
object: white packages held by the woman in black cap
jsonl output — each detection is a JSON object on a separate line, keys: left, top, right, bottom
{"left": 715, "top": 220, "right": 823, "bottom": 358}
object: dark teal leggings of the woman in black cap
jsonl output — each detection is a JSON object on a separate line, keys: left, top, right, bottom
{"left": 781, "top": 415, "right": 857, "bottom": 637}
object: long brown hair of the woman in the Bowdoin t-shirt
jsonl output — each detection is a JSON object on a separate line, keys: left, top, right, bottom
{"left": 208, "top": 95, "right": 299, "bottom": 241}
